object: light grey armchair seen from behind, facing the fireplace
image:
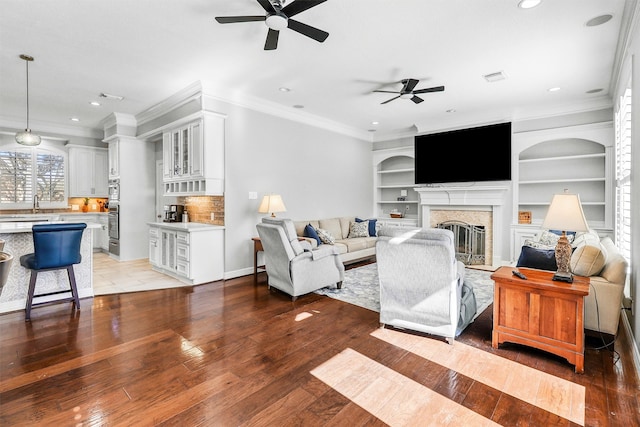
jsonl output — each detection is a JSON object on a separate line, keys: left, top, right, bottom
{"left": 376, "top": 227, "right": 464, "bottom": 344}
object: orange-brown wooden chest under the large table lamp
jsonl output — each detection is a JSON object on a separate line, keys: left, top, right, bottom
{"left": 491, "top": 267, "right": 589, "bottom": 373}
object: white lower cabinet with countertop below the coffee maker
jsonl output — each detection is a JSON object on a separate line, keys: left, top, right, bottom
{"left": 148, "top": 223, "right": 224, "bottom": 285}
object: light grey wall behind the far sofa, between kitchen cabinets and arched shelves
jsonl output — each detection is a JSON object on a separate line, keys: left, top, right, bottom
{"left": 208, "top": 103, "right": 373, "bottom": 277}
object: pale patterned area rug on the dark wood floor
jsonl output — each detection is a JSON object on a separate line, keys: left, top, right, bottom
{"left": 316, "top": 264, "right": 493, "bottom": 319}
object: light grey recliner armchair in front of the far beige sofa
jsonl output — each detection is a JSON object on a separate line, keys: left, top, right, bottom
{"left": 256, "top": 218, "right": 344, "bottom": 301}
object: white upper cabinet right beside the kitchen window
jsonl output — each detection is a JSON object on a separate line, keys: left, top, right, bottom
{"left": 67, "top": 145, "right": 109, "bottom": 197}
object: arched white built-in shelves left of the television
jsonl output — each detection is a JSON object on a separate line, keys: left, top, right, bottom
{"left": 373, "top": 146, "right": 420, "bottom": 226}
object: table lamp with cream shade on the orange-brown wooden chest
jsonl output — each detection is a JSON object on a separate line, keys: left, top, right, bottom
{"left": 542, "top": 190, "right": 589, "bottom": 283}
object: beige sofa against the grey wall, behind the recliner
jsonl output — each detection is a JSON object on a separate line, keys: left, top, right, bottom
{"left": 293, "top": 217, "right": 377, "bottom": 264}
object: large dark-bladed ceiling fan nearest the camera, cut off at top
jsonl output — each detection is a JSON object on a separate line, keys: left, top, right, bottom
{"left": 216, "top": 0, "right": 329, "bottom": 50}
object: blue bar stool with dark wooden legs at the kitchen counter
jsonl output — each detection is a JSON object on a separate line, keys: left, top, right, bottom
{"left": 20, "top": 223, "right": 87, "bottom": 320}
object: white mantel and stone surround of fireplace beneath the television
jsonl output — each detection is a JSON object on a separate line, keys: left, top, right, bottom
{"left": 415, "top": 185, "right": 509, "bottom": 266}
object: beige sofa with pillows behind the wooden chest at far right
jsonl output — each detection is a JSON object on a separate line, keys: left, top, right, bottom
{"left": 518, "top": 230, "right": 628, "bottom": 335}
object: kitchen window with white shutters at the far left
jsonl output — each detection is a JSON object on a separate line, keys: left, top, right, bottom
{"left": 0, "top": 148, "right": 66, "bottom": 209}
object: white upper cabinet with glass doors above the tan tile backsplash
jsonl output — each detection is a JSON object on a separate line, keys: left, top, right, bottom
{"left": 162, "top": 113, "right": 225, "bottom": 196}
